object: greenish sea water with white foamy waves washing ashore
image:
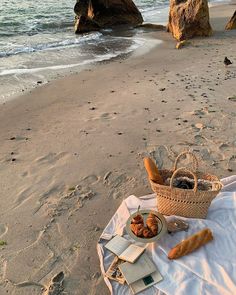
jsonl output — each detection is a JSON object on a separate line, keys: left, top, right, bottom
{"left": 0, "top": 0, "right": 220, "bottom": 103}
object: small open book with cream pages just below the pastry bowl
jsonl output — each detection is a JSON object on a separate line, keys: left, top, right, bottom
{"left": 105, "top": 235, "right": 145, "bottom": 263}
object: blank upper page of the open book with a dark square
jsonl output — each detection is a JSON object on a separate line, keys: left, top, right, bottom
{"left": 119, "top": 253, "right": 157, "bottom": 284}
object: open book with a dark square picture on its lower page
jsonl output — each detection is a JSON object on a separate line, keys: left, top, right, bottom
{"left": 119, "top": 253, "right": 162, "bottom": 294}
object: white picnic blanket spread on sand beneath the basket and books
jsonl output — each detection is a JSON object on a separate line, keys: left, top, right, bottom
{"left": 97, "top": 175, "right": 236, "bottom": 295}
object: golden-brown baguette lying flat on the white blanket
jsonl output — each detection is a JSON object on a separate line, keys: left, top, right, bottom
{"left": 168, "top": 228, "right": 213, "bottom": 259}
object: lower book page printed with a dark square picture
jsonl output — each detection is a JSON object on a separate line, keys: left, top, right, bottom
{"left": 130, "top": 270, "right": 163, "bottom": 294}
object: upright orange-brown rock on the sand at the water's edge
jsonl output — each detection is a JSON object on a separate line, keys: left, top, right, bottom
{"left": 167, "top": 0, "right": 212, "bottom": 41}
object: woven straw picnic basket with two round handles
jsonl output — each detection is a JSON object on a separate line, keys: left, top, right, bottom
{"left": 149, "top": 152, "right": 222, "bottom": 218}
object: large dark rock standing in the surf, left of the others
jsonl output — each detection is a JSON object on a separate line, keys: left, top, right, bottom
{"left": 74, "top": 0, "right": 143, "bottom": 33}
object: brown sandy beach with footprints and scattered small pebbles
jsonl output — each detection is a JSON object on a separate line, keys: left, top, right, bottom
{"left": 0, "top": 2, "right": 236, "bottom": 295}
